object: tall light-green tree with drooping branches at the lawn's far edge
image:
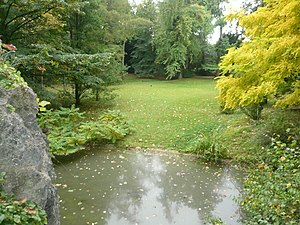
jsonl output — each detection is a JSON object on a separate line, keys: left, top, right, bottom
{"left": 155, "top": 0, "right": 210, "bottom": 78}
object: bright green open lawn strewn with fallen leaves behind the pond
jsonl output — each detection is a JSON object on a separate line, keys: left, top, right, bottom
{"left": 109, "top": 77, "right": 245, "bottom": 154}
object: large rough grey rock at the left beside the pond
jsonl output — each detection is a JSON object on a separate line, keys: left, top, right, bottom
{"left": 0, "top": 87, "right": 60, "bottom": 225}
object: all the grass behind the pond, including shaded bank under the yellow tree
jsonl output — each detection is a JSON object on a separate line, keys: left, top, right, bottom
{"left": 81, "top": 76, "right": 300, "bottom": 164}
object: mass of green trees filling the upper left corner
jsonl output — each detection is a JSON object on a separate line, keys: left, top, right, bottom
{"left": 0, "top": 0, "right": 132, "bottom": 106}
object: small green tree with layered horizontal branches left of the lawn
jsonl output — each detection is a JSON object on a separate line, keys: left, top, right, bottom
{"left": 18, "top": 45, "right": 124, "bottom": 106}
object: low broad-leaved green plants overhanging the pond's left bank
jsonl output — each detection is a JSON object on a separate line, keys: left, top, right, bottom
{"left": 39, "top": 106, "right": 131, "bottom": 156}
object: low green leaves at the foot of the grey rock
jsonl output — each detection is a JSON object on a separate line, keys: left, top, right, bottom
{"left": 0, "top": 173, "right": 47, "bottom": 225}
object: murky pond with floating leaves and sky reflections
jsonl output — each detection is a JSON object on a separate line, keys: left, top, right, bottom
{"left": 55, "top": 150, "right": 242, "bottom": 225}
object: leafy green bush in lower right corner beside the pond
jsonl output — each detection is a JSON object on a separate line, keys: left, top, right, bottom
{"left": 241, "top": 133, "right": 300, "bottom": 225}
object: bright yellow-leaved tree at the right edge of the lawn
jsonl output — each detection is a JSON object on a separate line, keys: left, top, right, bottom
{"left": 217, "top": 0, "right": 300, "bottom": 119}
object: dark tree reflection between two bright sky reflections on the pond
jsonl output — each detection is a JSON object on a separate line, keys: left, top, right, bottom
{"left": 158, "top": 154, "right": 222, "bottom": 223}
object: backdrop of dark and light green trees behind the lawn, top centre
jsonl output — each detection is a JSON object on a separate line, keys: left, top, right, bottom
{"left": 128, "top": 0, "right": 229, "bottom": 79}
